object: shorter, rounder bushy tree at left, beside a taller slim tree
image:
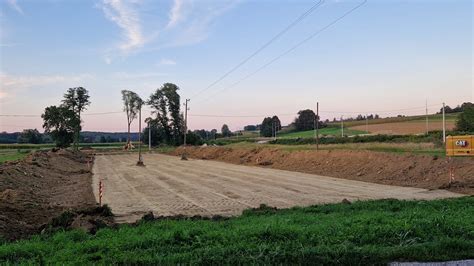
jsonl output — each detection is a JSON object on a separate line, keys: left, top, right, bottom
{"left": 41, "top": 106, "right": 81, "bottom": 148}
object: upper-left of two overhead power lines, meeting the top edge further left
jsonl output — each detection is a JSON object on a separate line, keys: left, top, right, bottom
{"left": 191, "top": 0, "right": 324, "bottom": 98}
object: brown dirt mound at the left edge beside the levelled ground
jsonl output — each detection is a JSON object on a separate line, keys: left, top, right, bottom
{"left": 0, "top": 150, "right": 100, "bottom": 240}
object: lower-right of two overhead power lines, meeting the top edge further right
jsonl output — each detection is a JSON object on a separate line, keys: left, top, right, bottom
{"left": 198, "top": 0, "right": 367, "bottom": 103}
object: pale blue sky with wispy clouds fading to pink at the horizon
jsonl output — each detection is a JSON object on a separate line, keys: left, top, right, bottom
{"left": 0, "top": 0, "right": 474, "bottom": 132}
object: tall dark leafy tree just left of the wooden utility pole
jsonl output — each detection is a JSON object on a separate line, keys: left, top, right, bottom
{"left": 147, "top": 83, "right": 184, "bottom": 145}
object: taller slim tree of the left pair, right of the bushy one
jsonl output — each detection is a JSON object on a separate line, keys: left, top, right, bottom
{"left": 62, "top": 87, "right": 90, "bottom": 150}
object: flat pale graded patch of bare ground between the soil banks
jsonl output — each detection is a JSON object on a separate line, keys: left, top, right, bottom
{"left": 93, "top": 154, "right": 461, "bottom": 222}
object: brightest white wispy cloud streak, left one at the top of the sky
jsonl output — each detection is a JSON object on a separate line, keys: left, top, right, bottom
{"left": 102, "top": 0, "right": 145, "bottom": 53}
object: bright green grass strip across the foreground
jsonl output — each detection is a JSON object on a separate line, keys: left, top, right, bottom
{"left": 0, "top": 197, "right": 474, "bottom": 265}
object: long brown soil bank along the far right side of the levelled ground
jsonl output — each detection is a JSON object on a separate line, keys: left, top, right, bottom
{"left": 171, "top": 147, "right": 474, "bottom": 195}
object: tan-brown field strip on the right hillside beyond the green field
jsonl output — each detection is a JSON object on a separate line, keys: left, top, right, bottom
{"left": 350, "top": 121, "right": 455, "bottom": 135}
